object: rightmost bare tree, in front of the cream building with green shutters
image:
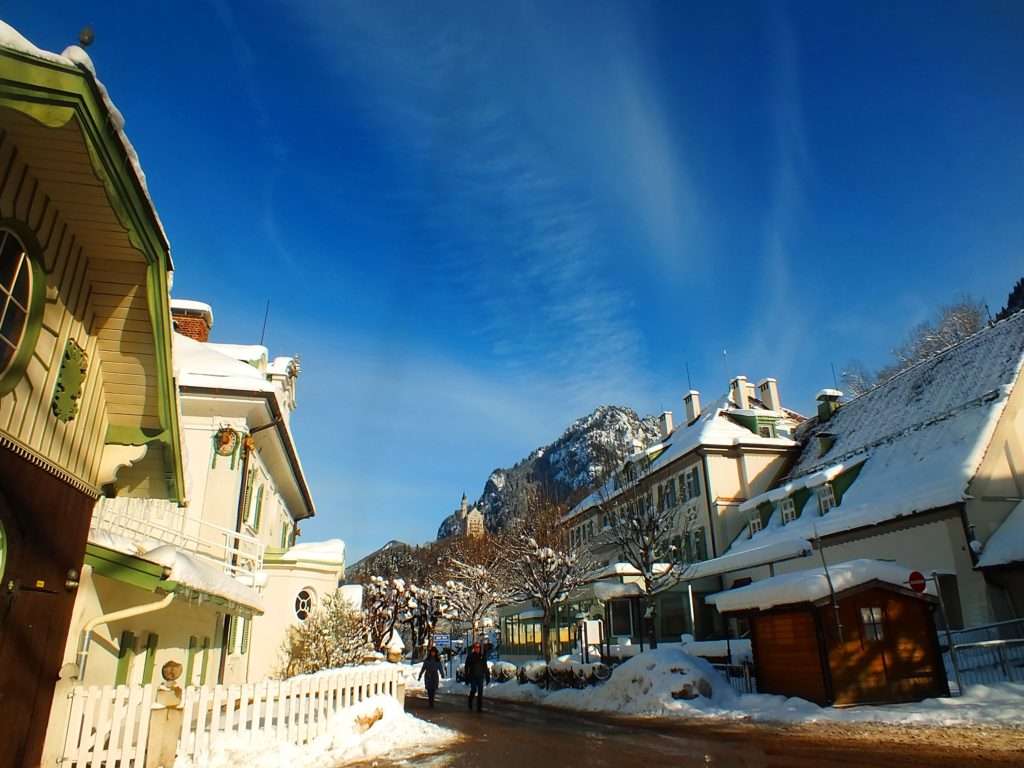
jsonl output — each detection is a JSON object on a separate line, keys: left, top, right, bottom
{"left": 596, "top": 451, "right": 692, "bottom": 648}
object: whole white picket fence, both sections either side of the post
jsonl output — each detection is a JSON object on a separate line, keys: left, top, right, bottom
{"left": 58, "top": 665, "right": 399, "bottom": 768}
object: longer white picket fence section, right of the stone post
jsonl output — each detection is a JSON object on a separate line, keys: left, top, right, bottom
{"left": 178, "top": 666, "right": 398, "bottom": 758}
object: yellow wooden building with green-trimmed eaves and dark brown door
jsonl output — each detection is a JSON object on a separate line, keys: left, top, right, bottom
{"left": 0, "top": 23, "right": 183, "bottom": 767}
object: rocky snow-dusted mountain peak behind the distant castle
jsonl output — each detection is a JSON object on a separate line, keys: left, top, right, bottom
{"left": 437, "top": 406, "right": 658, "bottom": 540}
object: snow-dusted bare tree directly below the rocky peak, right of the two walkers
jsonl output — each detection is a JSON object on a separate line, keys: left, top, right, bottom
{"left": 505, "top": 496, "right": 597, "bottom": 662}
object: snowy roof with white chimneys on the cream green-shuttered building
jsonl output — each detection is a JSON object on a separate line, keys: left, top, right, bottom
{"left": 563, "top": 394, "right": 797, "bottom": 519}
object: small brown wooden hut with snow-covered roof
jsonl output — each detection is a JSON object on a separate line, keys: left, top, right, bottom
{"left": 709, "top": 560, "right": 949, "bottom": 706}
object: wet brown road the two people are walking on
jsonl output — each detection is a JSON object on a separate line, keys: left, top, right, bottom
{"left": 350, "top": 695, "right": 1014, "bottom": 768}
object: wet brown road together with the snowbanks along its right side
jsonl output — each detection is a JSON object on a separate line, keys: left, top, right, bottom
{"left": 387, "top": 646, "right": 1024, "bottom": 768}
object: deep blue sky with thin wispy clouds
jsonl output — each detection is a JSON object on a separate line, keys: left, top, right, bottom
{"left": 6, "top": 0, "right": 1024, "bottom": 559}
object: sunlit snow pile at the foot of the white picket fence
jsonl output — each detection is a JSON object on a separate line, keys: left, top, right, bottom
{"left": 174, "top": 696, "right": 458, "bottom": 768}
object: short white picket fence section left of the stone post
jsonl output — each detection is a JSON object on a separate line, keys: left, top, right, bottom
{"left": 59, "top": 685, "right": 154, "bottom": 768}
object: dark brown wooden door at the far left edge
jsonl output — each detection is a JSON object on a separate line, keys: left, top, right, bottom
{"left": 0, "top": 449, "right": 92, "bottom": 768}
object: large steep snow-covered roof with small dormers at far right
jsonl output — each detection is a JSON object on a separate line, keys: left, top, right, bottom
{"left": 730, "top": 312, "right": 1024, "bottom": 552}
